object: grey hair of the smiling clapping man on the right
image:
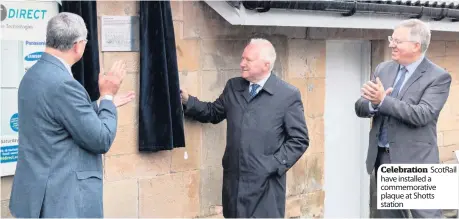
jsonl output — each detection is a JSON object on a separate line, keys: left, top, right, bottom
{"left": 397, "top": 19, "right": 431, "bottom": 53}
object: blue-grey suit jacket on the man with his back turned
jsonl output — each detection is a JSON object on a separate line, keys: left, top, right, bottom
{"left": 10, "top": 53, "right": 117, "bottom": 218}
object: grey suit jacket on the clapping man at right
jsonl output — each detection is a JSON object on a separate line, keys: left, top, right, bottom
{"left": 355, "top": 58, "right": 451, "bottom": 173}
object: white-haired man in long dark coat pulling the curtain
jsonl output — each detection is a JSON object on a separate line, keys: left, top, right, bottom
{"left": 182, "top": 39, "right": 309, "bottom": 218}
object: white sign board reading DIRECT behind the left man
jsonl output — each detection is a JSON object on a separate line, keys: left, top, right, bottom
{"left": 0, "top": 1, "right": 59, "bottom": 176}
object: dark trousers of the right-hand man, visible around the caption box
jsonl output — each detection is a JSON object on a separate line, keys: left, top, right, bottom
{"left": 374, "top": 148, "right": 442, "bottom": 218}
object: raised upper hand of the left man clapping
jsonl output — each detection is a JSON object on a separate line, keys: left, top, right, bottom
{"left": 99, "top": 61, "right": 126, "bottom": 96}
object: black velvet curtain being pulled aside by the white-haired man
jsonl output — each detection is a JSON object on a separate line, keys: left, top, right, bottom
{"left": 139, "top": 1, "right": 185, "bottom": 152}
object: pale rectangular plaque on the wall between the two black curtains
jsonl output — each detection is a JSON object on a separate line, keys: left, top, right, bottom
{"left": 101, "top": 16, "right": 139, "bottom": 51}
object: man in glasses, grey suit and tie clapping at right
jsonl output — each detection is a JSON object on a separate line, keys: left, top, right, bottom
{"left": 355, "top": 19, "right": 451, "bottom": 218}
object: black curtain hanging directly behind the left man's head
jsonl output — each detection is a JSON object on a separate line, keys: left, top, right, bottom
{"left": 59, "top": 1, "right": 100, "bottom": 101}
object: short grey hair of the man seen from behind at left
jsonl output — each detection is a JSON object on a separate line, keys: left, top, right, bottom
{"left": 46, "top": 12, "right": 88, "bottom": 52}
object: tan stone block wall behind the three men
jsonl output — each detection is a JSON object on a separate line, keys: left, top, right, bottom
{"left": 1, "top": 1, "right": 459, "bottom": 218}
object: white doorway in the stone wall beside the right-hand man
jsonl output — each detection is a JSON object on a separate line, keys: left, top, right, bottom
{"left": 324, "top": 40, "right": 371, "bottom": 218}
